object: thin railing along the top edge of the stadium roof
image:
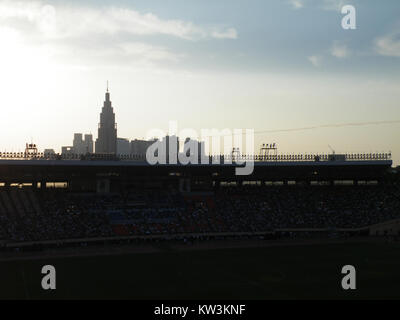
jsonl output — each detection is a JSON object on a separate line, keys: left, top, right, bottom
{"left": 0, "top": 152, "right": 392, "bottom": 163}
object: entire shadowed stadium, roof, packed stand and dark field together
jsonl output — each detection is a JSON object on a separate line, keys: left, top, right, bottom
{"left": 0, "top": 154, "right": 400, "bottom": 299}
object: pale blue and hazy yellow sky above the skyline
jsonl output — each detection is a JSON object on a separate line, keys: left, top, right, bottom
{"left": 0, "top": 0, "right": 400, "bottom": 165}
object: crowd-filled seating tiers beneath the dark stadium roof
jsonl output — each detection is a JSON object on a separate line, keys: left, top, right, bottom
{"left": 0, "top": 185, "right": 400, "bottom": 242}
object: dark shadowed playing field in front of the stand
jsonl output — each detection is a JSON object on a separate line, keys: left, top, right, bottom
{"left": 0, "top": 243, "right": 400, "bottom": 299}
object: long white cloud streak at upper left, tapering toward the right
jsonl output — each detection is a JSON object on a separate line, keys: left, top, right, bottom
{"left": 0, "top": 1, "right": 237, "bottom": 40}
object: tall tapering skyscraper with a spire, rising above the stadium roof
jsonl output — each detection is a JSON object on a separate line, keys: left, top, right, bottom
{"left": 95, "top": 81, "right": 117, "bottom": 154}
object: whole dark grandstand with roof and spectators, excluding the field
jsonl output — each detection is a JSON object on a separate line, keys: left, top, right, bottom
{"left": 0, "top": 154, "right": 400, "bottom": 250}
